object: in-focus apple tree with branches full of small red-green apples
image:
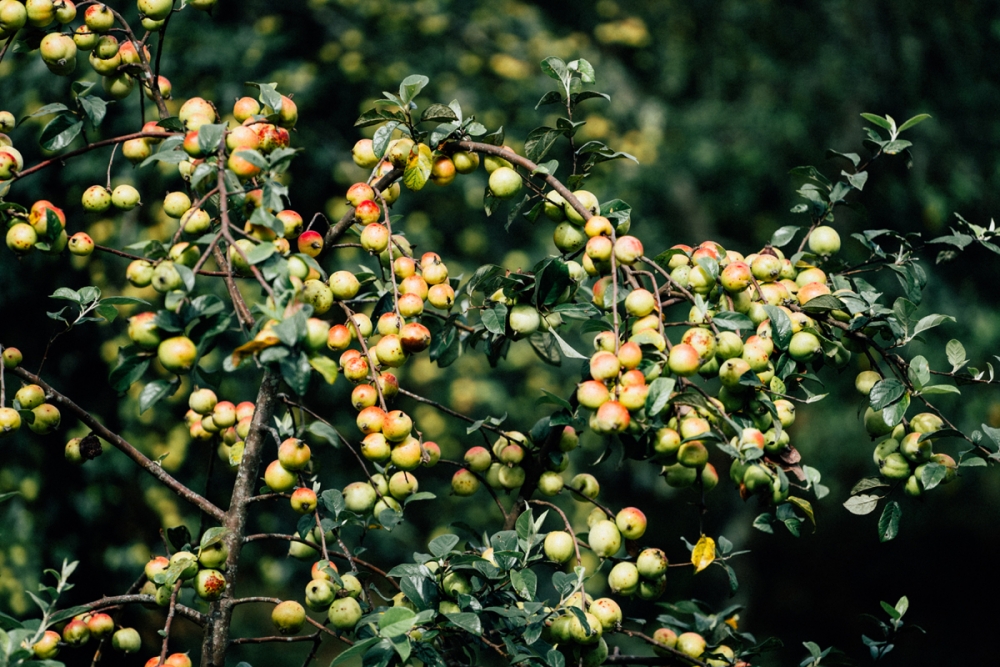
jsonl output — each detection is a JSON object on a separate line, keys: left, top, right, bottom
{"left": 0, "top": 0, "right": 1000, "bottom": 667}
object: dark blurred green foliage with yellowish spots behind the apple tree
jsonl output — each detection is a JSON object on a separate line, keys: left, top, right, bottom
{"left": 0, "top": 0, "right": 1000, "bottom": 664}
